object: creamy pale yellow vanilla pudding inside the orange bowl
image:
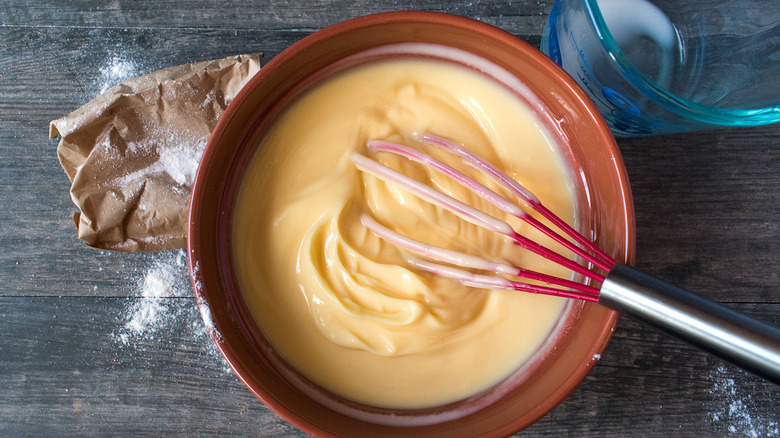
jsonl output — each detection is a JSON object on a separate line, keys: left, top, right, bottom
{"left": 232, "top": 58, "right": 576, "bottom": 408}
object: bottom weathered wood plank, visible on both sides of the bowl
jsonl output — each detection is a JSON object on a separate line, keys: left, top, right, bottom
{"left": 0, "top": 297, "right": 780, "bottom": 437}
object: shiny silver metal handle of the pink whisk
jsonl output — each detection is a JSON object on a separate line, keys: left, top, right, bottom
{"left": 599, "top": 265, "right": 780, "bottom": 384}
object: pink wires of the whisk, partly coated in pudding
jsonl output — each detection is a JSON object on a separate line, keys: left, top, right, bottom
{"left": 351, "top": 134, "right": 616, "bottom": 301}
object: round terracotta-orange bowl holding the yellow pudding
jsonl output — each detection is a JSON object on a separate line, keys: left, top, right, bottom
{"left": 188, "top": 12, "right": 634, "bottom": 437}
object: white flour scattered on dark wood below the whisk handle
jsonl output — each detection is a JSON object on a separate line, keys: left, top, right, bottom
{"left": 710, "top": 365, "right": 780, "bottom": 438}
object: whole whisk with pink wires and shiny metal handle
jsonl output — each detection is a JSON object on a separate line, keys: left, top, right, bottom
{"left": 351, "top": 134, "right": 780, "bottom": 384}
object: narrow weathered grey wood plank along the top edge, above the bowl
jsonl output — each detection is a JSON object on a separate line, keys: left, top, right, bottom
{"left": 0, "top": 0, "right": 552, "bottom": 36}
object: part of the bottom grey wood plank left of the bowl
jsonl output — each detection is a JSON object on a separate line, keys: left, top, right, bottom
{"left": 0, "top": 297, "right": 298, "bottom": 436}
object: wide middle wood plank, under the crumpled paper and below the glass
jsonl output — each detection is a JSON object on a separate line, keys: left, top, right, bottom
{"left": 0, "top": 24, "right": 780, "bottom": 302}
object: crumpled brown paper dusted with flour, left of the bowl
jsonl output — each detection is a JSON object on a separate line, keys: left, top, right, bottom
{"left": 49, "top": 54, "right": 261, "bottom": 252}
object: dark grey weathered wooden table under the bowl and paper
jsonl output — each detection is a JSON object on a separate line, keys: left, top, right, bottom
{"left": 0, "top": 0, "right": 780, "bottom": 438}
